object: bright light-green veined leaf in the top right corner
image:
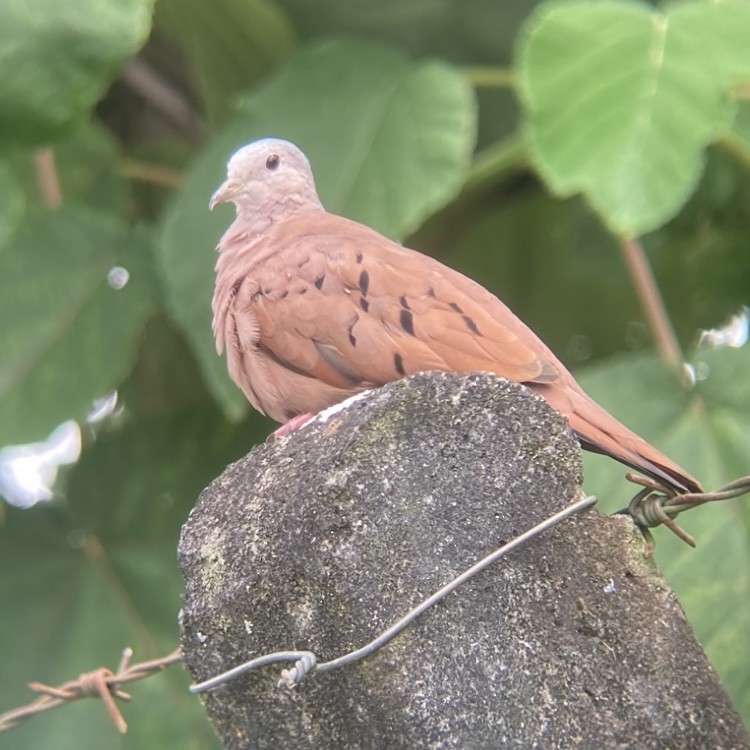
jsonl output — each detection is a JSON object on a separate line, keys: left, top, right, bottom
{"left": 518, "top": 0, "right": 750, "bottom": 235}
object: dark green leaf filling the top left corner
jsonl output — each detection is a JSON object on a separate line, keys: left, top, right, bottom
{"left": 0, "top": 0, "right": 153, "bottom": 149}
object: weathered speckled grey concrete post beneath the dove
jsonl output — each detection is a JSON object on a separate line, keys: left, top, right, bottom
{"left": 180, "top": 374, "right": 750, "bottom": 750}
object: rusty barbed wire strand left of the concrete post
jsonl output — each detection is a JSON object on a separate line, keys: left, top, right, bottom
{"left": 0, "top": 648, "right": 182, "bottom": 734}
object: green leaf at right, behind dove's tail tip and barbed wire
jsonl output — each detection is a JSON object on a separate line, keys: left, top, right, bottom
{"left": 579, "top": 346, "right": 750, "bottom": 722}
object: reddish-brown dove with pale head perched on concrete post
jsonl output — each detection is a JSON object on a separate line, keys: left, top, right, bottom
{"left": 209, "top": 138, "right": 701, "bottom": 494}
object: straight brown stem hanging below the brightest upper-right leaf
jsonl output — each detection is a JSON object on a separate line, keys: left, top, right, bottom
{"left": 620, "top": 238, "right": 684, "bottom": 369}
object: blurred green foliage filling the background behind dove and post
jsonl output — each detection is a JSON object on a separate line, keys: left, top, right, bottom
{"left": 0, "top": 0, "right": 750, "bottom": 750}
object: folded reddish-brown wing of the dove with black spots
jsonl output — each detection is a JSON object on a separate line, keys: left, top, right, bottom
{"left": 214, "top": 212, "right": 558, "bottom": 420}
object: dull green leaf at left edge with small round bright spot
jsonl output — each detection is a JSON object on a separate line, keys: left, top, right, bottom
{"left": 0, "top": 208, "right": 155, "bottom": 445}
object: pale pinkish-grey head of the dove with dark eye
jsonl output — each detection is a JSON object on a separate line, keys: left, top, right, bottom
{"left": 209, "top": 138, "right": 322, "bottom": 218}
